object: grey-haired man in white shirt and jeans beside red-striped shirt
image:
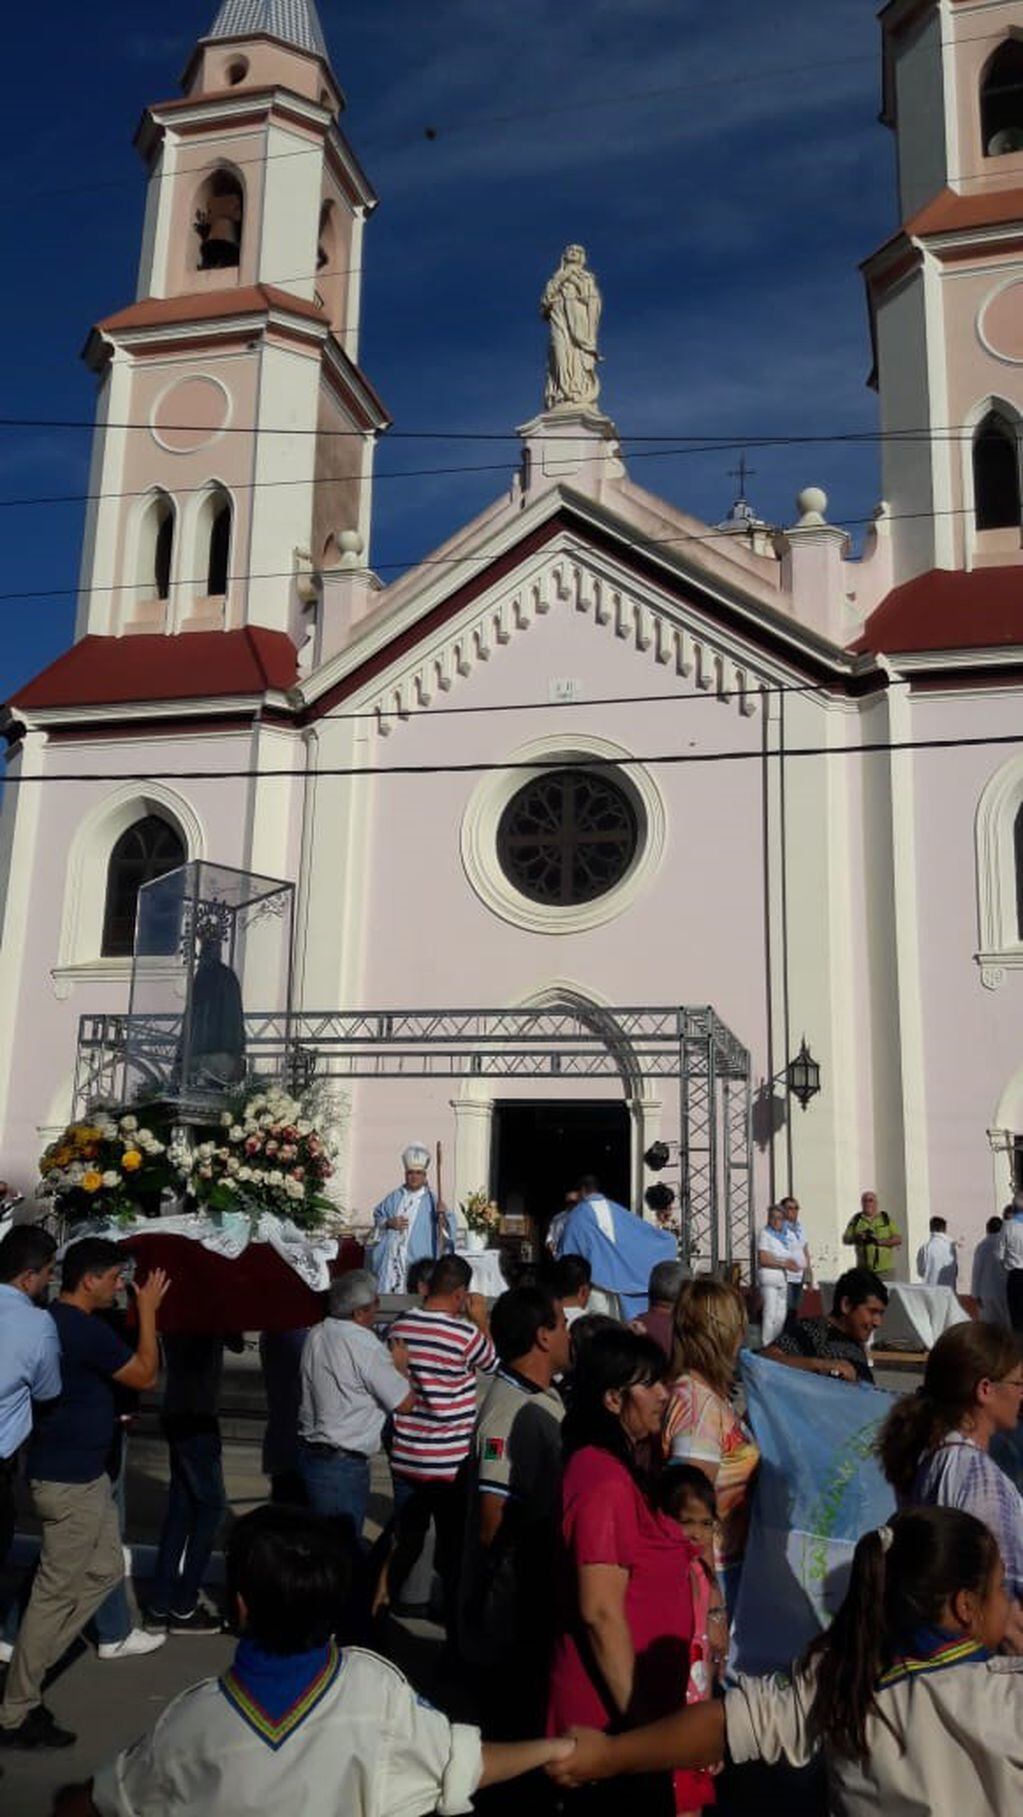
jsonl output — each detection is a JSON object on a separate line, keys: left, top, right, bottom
{"left": 298, "top": 1268, "right": 416, "bottom": 1539}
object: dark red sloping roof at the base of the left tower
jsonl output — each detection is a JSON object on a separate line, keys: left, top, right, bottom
{"left": 13, "top": 625, "right": 298, "bottom": 712}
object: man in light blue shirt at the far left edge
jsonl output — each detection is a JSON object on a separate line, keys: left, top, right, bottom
{"left": 0, "top": 1225, "right": 60, "bottom": 1613}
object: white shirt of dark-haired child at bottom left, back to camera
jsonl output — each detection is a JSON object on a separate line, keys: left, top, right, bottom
{"left": 93, "top": 1646, "right": 483, "bottom": 1817}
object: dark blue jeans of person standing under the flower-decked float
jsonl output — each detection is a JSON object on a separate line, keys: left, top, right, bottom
{"left": 151, "top": 1430, "right": 227, "bottom": 1615}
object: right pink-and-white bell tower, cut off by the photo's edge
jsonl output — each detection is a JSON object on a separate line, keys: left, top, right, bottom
{"left": 863, "top": 0, "right": 1023, "bottom": 581}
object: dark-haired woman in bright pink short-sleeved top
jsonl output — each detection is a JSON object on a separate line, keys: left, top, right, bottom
{"left": 547, "top": 1326, "right": 698, "bottom": 1817}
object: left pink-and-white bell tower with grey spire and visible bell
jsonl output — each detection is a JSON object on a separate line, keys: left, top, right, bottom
{"left": 76, "top": 0, "right": 387, "bottom": 643}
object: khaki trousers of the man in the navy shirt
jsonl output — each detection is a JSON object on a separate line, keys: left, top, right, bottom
{"left": 0, "top": 1475, "right": 124, "bottom": 1728}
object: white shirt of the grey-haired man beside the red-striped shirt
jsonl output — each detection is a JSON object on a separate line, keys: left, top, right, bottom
{"left": 298, "top": 1319, "right": 409, "bottom": 1457}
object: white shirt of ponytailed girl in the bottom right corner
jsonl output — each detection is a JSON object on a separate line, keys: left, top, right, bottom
{"left": 725, "top": 1659, "right": 1023, "bottom": 1817}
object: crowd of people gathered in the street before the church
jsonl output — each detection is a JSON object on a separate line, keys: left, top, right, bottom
{"left": 0, "top": 1185, "right": 1023, "bottom": 1817}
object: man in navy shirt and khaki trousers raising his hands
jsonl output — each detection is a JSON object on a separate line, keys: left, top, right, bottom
{"left": 0, "top": 1237, "right": 169, "bottom": 1748}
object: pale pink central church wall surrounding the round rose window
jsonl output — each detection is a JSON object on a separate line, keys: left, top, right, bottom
{"left": 339, "top": 609, "right": 769, "bottom": 1208}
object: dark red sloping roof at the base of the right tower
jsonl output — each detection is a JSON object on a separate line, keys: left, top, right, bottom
{"left": 852, "top": 567, "right": 1023, "bottom": 654}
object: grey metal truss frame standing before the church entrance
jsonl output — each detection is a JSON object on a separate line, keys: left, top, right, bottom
{"left": 74, "top": 1003, "right": 752, "bottom": 1266}
